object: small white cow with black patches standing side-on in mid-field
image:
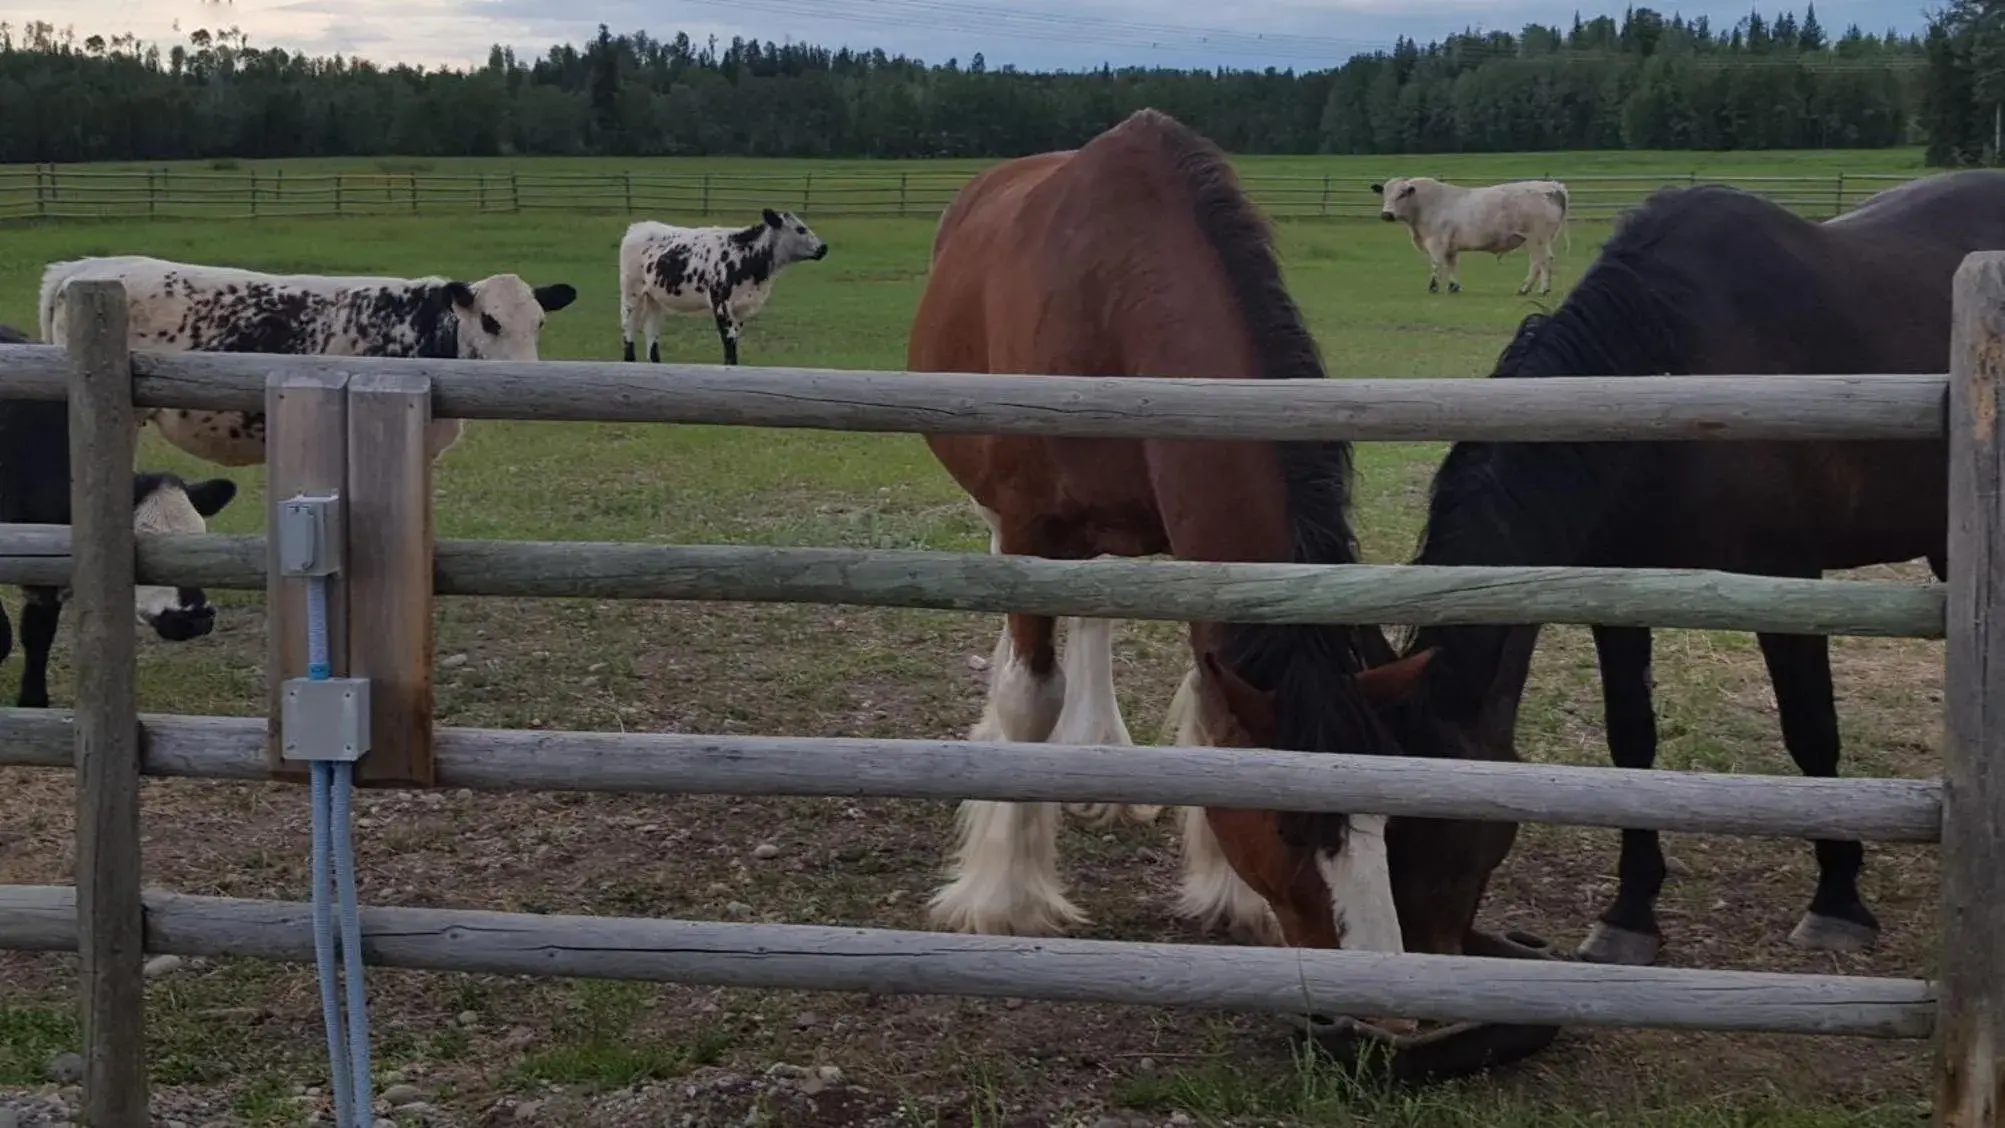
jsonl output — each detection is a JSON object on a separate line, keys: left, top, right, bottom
{"left": 620, "top": 208, "right": 828, "bottom": 365}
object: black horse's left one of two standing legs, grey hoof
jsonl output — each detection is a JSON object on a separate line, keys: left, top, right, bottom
{"left": 1578, "top": 627, "right": 1664, "bottom": 964}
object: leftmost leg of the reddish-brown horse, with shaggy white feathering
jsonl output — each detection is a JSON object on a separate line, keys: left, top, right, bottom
{"left": 930, "top": 509, "right": 1087, "bottom": 936}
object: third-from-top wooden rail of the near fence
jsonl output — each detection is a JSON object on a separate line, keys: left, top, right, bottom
{"left": 0, "top": 709, "right": 1943, "bottom": 841}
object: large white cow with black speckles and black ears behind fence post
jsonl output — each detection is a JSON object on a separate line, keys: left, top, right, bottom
{"left": 42, "top": 254, "right": 577, "bottom": 467}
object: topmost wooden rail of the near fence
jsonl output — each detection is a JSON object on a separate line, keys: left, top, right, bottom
{"left": 0, "top": 345, "right": 1947, "bottom": 443}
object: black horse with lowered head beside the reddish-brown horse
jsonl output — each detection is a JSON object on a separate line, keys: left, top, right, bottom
{"left": 1391, "top": 172, "right": 2005, "bottom": 964}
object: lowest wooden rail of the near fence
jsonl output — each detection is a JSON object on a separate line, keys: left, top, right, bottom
{"left": 0, "top": 886, "right": 1935, "bottom": 1038}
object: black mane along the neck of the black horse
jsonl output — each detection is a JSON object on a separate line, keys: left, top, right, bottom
{"left": 1401, "top": 186, "right": 1700, "bottom": 719}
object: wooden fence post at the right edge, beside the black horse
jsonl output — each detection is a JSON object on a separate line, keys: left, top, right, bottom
{"left": 1935, "top": 250, "right": 2005, "bottom": 1128}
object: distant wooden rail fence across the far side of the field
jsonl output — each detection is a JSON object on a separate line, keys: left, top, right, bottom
{"left": 0, "top": 160, "right": 1911, "bottom": 220}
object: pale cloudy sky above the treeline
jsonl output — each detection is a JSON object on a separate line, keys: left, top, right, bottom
{"left": 0, "top": 0, "right": 1933, "bottom": 68}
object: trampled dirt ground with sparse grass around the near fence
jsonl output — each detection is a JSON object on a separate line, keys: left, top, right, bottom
{"left": 0, "top": 556, "right": 1941, "bottom": 1128}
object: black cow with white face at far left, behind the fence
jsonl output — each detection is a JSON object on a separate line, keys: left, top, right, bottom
{"left": 0, "top": 325, "right": 237, "bottom": 709}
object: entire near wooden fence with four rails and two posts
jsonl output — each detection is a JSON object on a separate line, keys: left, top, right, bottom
{"left": 0, "top": 262, "right": 2005, "bottom": 1128}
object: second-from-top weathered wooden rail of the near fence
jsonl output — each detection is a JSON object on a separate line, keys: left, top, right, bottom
{"left": 0, "top": 525, "right": 1945, "bottom": 639}
